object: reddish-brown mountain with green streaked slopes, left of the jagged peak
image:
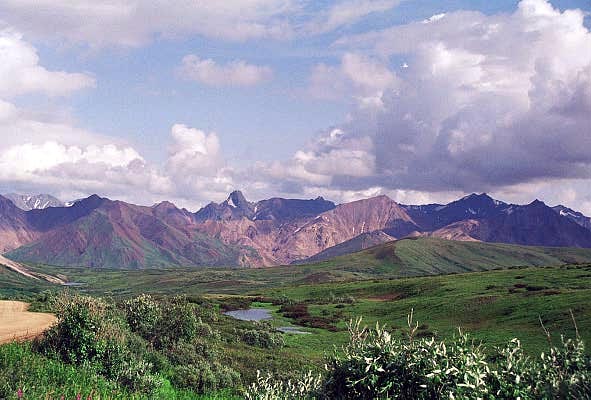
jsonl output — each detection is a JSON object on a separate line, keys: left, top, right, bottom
{"left": 8, "top": 199, "right": 257, "bottom": 268}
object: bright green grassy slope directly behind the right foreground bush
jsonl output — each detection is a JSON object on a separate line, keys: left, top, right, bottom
{"left": 268, "top": 265, "right": 591, "bottom": 351}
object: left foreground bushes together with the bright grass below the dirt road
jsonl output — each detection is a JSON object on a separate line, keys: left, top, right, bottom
{"left": 0, "top": 294, "right": 283, "bottom": 399}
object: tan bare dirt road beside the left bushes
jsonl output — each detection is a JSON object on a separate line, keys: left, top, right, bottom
{"left": 0, "top": 301, "right": 57, "bottom": 344}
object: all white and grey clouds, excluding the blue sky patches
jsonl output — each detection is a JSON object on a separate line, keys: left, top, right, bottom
{"left": 0, "top": 0, "right": 591, "bottom": 216}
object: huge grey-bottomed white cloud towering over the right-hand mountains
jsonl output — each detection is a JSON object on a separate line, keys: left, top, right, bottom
{"left": 260, "top": 0, "right": 591, "bottom": 208}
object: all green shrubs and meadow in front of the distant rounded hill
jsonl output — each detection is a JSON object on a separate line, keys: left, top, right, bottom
{"left": 0, "top": 258, "right": 591, "bottom": 400}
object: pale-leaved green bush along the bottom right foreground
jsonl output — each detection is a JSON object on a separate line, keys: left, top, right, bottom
{"left": 246, "top": 314, "right": 591, "bottom": 400}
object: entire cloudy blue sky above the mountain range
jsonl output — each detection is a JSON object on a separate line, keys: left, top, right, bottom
{"left": 0, "top": 0, "right": 591, "bottom": 215}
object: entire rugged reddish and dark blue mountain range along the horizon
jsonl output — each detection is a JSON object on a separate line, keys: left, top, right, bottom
{"left": 0, "top": 191, "right": 591, "bottom": 268}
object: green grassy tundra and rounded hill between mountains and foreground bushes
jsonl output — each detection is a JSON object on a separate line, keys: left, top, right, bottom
{"left": 0, "top": 239, "right": 591, "bottom": 362}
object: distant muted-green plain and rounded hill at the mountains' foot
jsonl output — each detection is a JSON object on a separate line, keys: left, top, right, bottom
{"left": 16, "top": 238, "right": 591, "bottom": 296}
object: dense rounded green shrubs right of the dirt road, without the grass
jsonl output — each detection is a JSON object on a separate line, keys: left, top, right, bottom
{"left": 18, "top": 294, "right": 253, "bottom": 398}
